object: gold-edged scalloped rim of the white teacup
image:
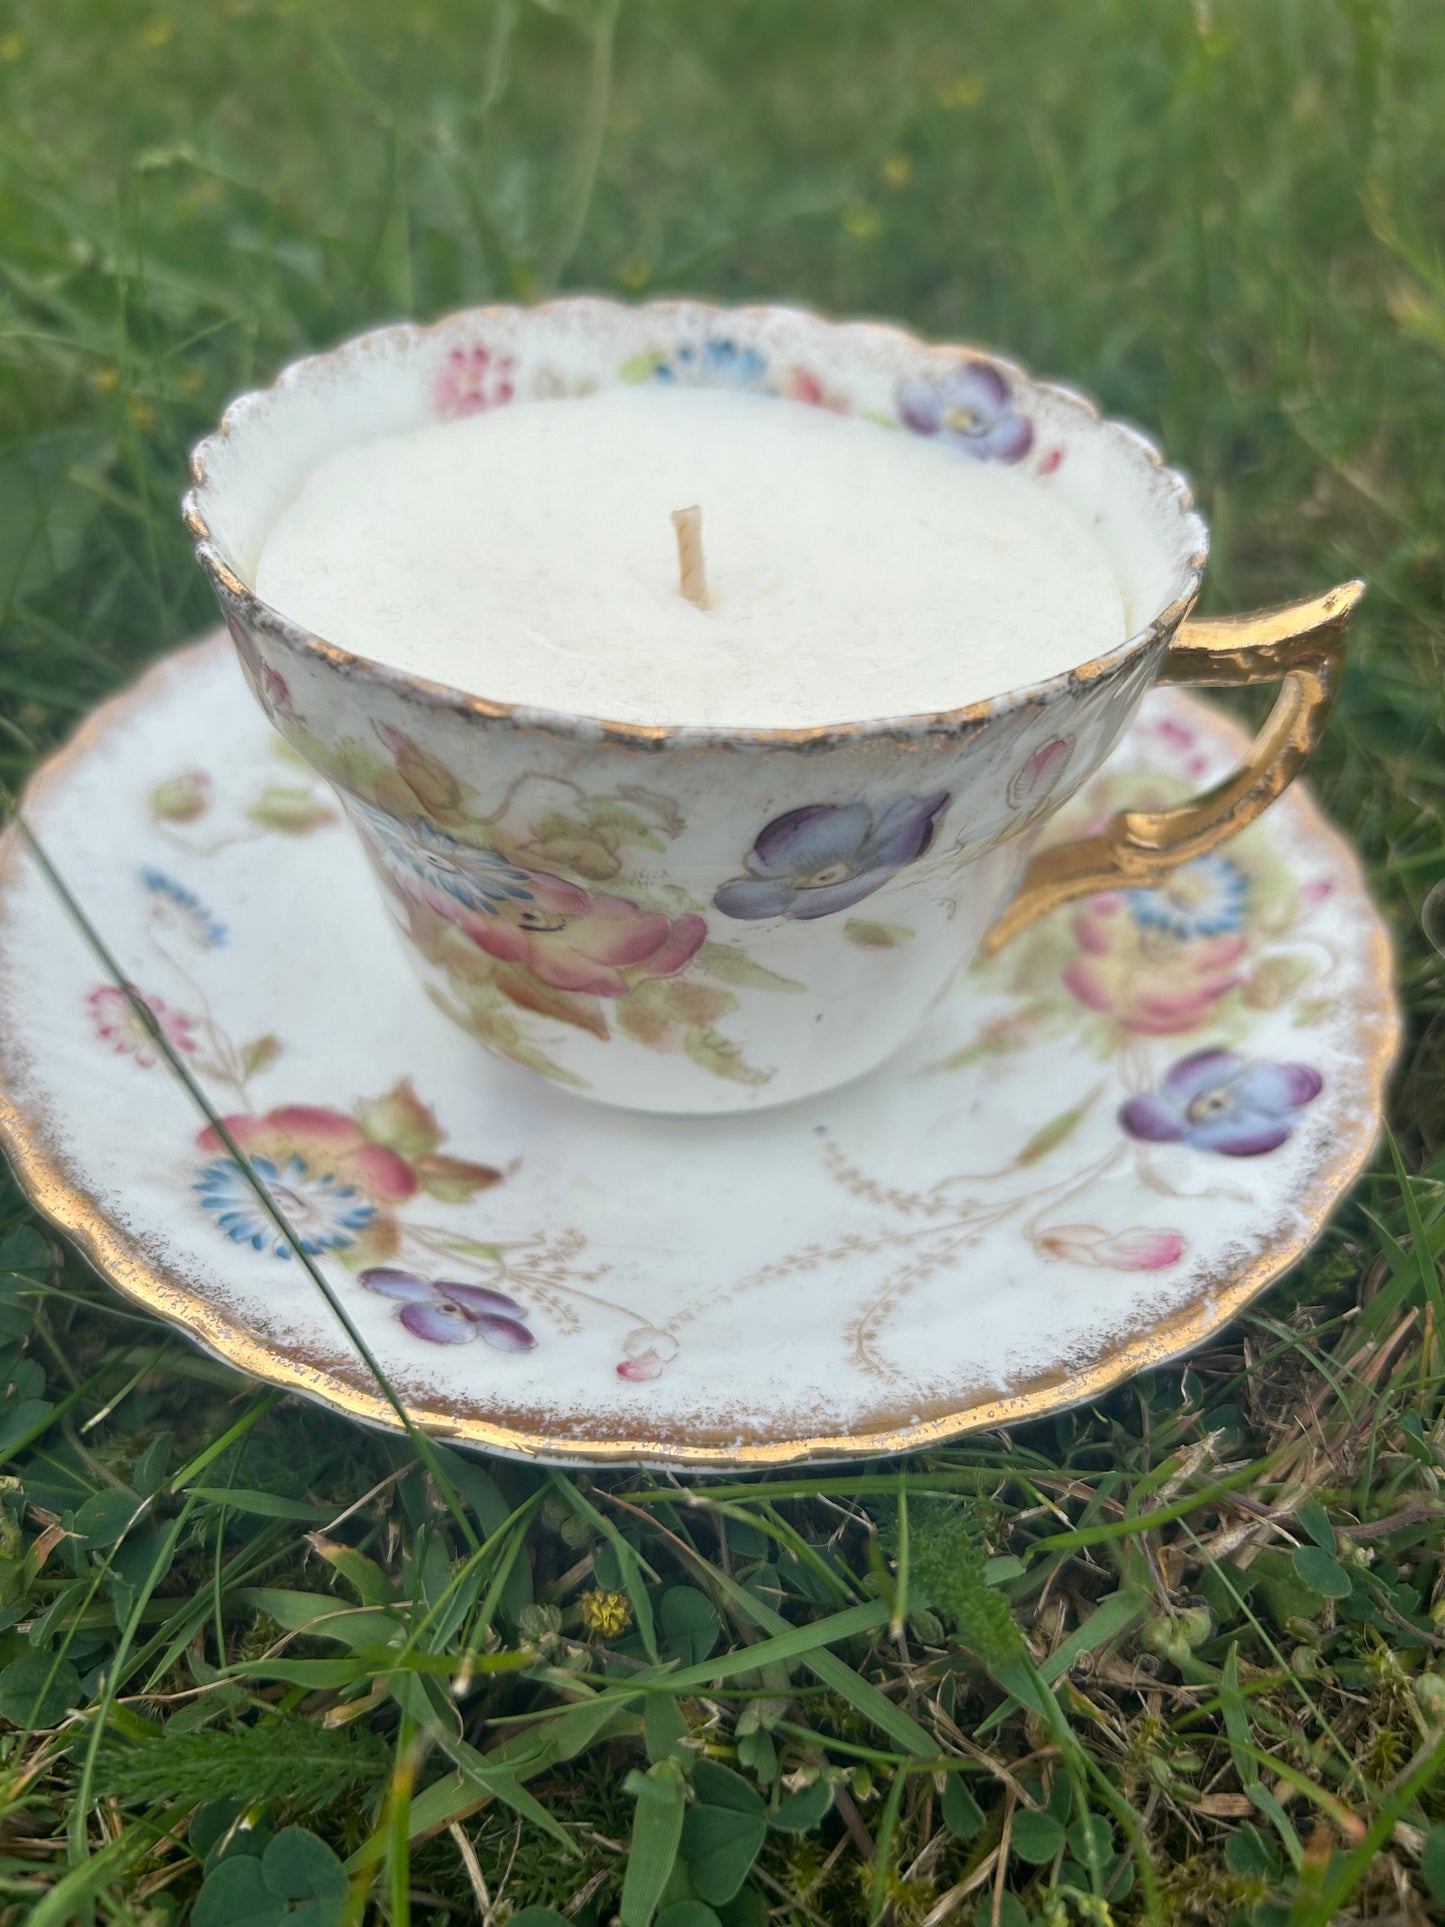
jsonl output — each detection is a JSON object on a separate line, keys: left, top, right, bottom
{"left": 181, "top": 295, "right": 1208, "bottom": 750}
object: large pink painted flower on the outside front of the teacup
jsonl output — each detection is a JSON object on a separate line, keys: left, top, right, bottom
{"left": 466, "top": 871, "right": 707, "bottom": 996}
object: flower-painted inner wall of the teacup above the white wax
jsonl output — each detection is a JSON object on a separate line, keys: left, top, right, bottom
{"left": 185, "top": 297, "right": 1208, "bottom": 720}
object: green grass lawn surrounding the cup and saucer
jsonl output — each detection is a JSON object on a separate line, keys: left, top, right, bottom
{"left": 0, "top": 0, "right": 1445, "bottom": 1927}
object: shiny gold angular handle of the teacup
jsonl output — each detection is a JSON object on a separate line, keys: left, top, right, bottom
{"left": 981, "top": 582, "right": 1364, "bottom": 956}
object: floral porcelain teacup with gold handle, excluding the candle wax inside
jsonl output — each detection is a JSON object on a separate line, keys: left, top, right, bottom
{"left": 185, "top": 299, "right": 1362, "bottom": 1114}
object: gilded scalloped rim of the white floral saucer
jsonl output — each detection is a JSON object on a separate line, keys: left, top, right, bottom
{"left": 0, "top": 634, "right": 1401, "bottom": 1472}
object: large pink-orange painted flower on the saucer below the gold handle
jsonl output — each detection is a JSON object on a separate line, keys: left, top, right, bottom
{"left": 1064, "top": 890, "right": 1248, "bottom": 1037}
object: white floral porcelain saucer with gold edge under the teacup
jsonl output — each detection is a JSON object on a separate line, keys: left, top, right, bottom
{"left": 0, "top": 638, "right": 1399, "bottom": 1468}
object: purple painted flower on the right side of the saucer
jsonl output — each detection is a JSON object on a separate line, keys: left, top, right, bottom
{"left": 1119, "top": 1050, "right": 1324, "bottom": 1158}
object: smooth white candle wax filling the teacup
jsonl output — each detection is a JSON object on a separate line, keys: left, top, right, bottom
{"left": 256, "top": 385, "right": 1125, "bottom": 728}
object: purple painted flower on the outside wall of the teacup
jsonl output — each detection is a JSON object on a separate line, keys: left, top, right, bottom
{"left": 713, "top": 790, "right": 948, "bottom": 921}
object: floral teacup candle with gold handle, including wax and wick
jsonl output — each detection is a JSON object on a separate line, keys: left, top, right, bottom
{"left": 185, "top": 299, "right": 1360, "bottom": 1112}
